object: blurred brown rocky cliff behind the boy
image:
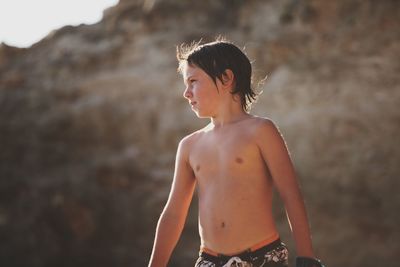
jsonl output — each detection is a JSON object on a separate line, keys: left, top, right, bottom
{"left": 0, "top": 0, "right": 400, "bottom": 267}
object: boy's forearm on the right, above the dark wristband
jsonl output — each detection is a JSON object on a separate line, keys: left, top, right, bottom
{"left": 285, "top": 193, "right": 315, "bottom": 257}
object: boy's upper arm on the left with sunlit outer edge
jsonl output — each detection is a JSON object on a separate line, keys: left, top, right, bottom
{"left": 165, "top": 137, "right": 196, "bottom": 218}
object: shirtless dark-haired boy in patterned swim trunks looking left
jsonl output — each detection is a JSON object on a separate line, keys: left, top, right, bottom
{"left": 149, "top": 40, "right": 322, "bottom": 267}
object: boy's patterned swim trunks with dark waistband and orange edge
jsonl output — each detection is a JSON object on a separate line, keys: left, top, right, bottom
{"left": 195, "top": 238, "right": 288, "bottom": 267}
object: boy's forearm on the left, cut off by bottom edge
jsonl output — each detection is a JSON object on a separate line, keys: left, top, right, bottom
{"left": 149, "top": 212, "right": 185, "bottom": 267}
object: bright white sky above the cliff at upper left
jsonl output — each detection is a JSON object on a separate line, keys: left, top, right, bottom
{"left": 0, "top": 0, "right": 118, "bottom": 47}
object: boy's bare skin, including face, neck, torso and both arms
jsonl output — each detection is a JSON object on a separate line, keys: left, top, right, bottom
{"left": 149, "top": 64, "right": 314, "bottom": 267}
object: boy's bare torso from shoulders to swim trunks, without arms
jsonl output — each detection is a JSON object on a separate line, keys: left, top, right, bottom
{"left": 189, "top": 117, "right": 277, "bottom": 254}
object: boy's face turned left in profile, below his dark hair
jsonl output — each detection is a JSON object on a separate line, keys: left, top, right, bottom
{"left": 183, "top": 63, "right": 221, "bottom": 118}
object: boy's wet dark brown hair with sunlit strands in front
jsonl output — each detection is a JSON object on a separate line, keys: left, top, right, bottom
{"left": 176, "top": 38, "right": 257, "bottom": 111}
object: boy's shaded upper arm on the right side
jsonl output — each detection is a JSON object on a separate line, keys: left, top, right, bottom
{"left": 257, "top": 119, "right": 299, "bottom": 200}
